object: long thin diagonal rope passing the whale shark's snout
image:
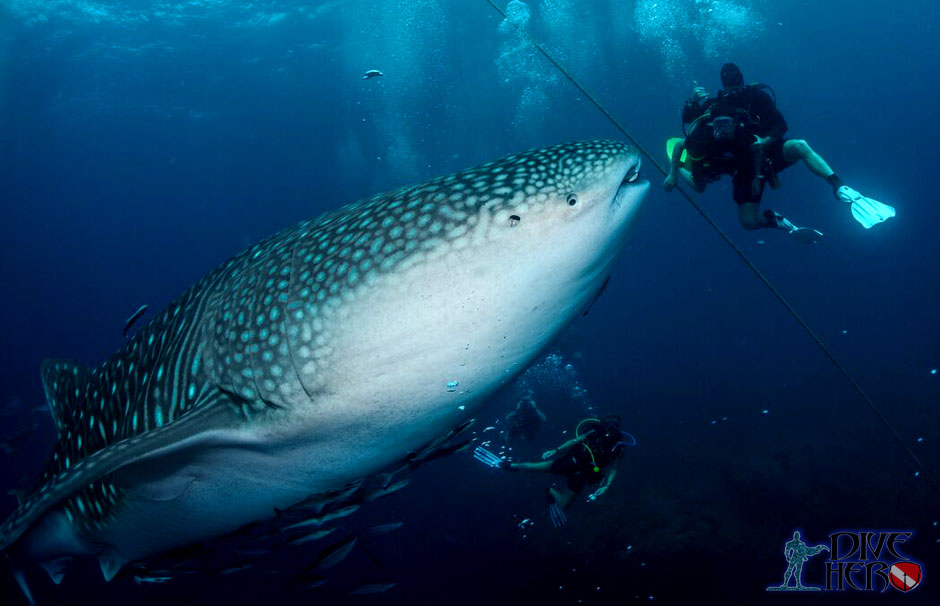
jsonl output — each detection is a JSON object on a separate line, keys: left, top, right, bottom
{"left": 486, "top": 0, "right": 940, "bottom": 493}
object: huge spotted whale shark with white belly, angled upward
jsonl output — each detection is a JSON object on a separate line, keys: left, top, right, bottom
{"left": 0, "top": 141, "right": 649, "bottom": 595}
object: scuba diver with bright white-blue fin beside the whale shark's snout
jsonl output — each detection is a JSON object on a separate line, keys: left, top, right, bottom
{"left": 663, "top": 63, "right": 895, "bottom": 242}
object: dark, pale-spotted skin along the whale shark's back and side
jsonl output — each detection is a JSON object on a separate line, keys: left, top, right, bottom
{"left": 0, "top": 141, "right": 632, "bottom": 560}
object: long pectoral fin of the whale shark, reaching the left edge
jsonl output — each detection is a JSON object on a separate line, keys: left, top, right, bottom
{"left": 0, "top": 395, "right": 244, "bottom": 550}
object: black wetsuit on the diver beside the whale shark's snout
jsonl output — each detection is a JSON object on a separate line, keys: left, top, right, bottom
{"left": 682, "top": 84, "right": 795, "bottom": 204}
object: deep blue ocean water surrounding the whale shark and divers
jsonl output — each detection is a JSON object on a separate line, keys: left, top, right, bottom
{"left": 0, "top": 0, "right": 940, "bottom": 604}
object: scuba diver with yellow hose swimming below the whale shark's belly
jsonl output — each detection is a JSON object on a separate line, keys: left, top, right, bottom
{"left": 473, "top": 415, "right": 636, "bottom": 528}
